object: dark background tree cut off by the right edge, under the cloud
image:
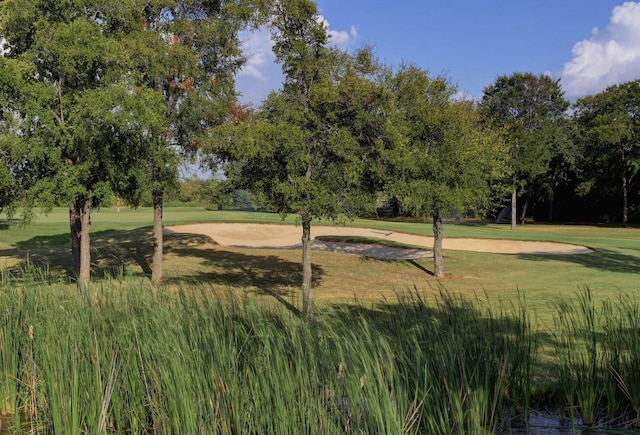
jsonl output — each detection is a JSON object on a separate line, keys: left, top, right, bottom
{"left": 574, "top": 80, "right": 640, "bottom": 225}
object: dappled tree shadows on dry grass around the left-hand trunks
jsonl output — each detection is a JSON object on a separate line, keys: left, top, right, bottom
{"left": 0, "top": 228, "right": 324, "bottom": 312}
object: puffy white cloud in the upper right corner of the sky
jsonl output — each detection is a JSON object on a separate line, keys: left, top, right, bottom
{"left": 560, "top": 2, "right": 640, "bottom": 97}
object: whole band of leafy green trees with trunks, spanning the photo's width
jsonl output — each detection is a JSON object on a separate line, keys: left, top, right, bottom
{"left": 0, "top": 0, "right": 640, "bottom": 315}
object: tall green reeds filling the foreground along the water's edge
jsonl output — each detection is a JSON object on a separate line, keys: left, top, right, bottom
{"left": 0, "top": 277, "right": 640, "bottom": 434}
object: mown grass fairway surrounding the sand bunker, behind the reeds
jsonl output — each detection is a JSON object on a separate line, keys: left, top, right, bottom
{"left": 0, "top": 207, "right": 640, "bottom": 319}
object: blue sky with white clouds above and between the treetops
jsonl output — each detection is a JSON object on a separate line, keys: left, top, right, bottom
{"left": 237, "top": 0, "right": 640, "bottom": 106}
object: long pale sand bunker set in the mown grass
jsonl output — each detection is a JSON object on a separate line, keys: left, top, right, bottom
{"left": 165, "top": 223, "right": 592, "bottom": 259}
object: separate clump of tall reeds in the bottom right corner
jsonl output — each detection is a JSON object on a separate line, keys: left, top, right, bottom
{"left": 555, "top": 288, "right": 640, "bottom": 428}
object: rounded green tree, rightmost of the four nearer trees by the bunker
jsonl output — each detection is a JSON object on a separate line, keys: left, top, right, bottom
{"left": 385, "top": 65, "right": 505, "bottom": 278}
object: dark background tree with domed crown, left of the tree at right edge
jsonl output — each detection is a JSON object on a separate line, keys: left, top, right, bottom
{"left": 480, "top": 73, "right": 569, "bottom": 229}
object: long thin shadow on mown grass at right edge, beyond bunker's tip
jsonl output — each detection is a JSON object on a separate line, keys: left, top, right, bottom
{"left": 519, "top": 248, "right": 640, "bottom": 273}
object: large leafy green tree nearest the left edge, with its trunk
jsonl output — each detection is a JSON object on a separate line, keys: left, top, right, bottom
{"left": 0, "top": 0, "right": 162, "bottom": 285}
